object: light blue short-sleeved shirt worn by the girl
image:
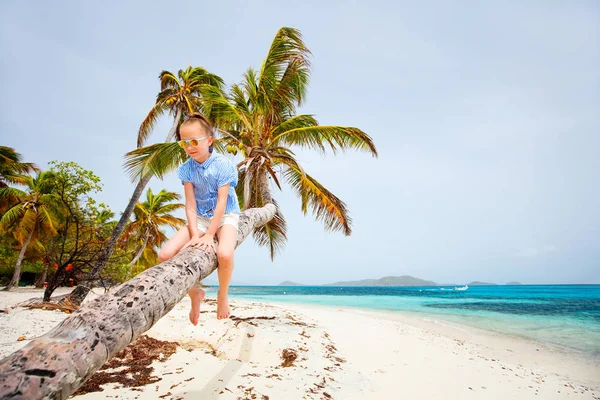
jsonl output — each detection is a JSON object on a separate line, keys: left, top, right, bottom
{"left": 177, "top": 152, "right": 240, "bottom": 218}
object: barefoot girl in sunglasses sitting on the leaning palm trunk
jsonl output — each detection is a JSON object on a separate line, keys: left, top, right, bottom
{"left": 158, "top": 113, "right": 240, "bottom": 325}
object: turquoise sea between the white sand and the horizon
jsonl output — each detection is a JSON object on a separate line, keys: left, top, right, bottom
{"left": 205, "top": 285, "right": 600, "bottom": 359}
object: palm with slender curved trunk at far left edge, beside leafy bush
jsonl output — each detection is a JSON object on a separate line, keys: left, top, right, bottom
{"left": 0, "top": 172, "right": 61, "bottom": 290}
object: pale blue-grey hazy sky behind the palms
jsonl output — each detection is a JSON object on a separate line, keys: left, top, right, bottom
{"left": 0, "top": 0, "right": 600, "bottom": 285}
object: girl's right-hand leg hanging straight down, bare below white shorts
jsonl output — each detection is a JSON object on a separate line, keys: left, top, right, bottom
{"left": 217, "top": 225, "right": 237, "bottom": 319}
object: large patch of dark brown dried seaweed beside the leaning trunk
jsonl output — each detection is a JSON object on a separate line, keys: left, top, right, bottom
{"left": 74, "top": 335, "right": 178, "bottom": 395}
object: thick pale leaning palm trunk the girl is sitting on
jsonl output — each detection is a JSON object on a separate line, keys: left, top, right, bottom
{"left": 0, "top": 204, "right": 275, "bottom": 400}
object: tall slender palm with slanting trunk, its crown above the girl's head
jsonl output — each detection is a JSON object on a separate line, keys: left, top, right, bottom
{"left": 62, "top": 67, "right": 223, "bottom": 307}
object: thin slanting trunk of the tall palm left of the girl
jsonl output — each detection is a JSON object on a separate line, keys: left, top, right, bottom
{"left": 60, "top": 110, "right": 181, "bottom": 308}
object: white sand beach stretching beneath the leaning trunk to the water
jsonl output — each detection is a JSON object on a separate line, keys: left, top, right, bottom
{"left": 0, "top": 288, "right": 600, "bottom": 400}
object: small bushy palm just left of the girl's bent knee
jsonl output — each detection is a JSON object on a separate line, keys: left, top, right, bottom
{"left": 125, "top": 189, "right": 185, "bottom": 279}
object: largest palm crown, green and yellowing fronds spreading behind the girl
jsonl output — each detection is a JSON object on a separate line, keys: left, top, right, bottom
{"left": 126, "top": 28, "right": 377, "bottom": 258}
